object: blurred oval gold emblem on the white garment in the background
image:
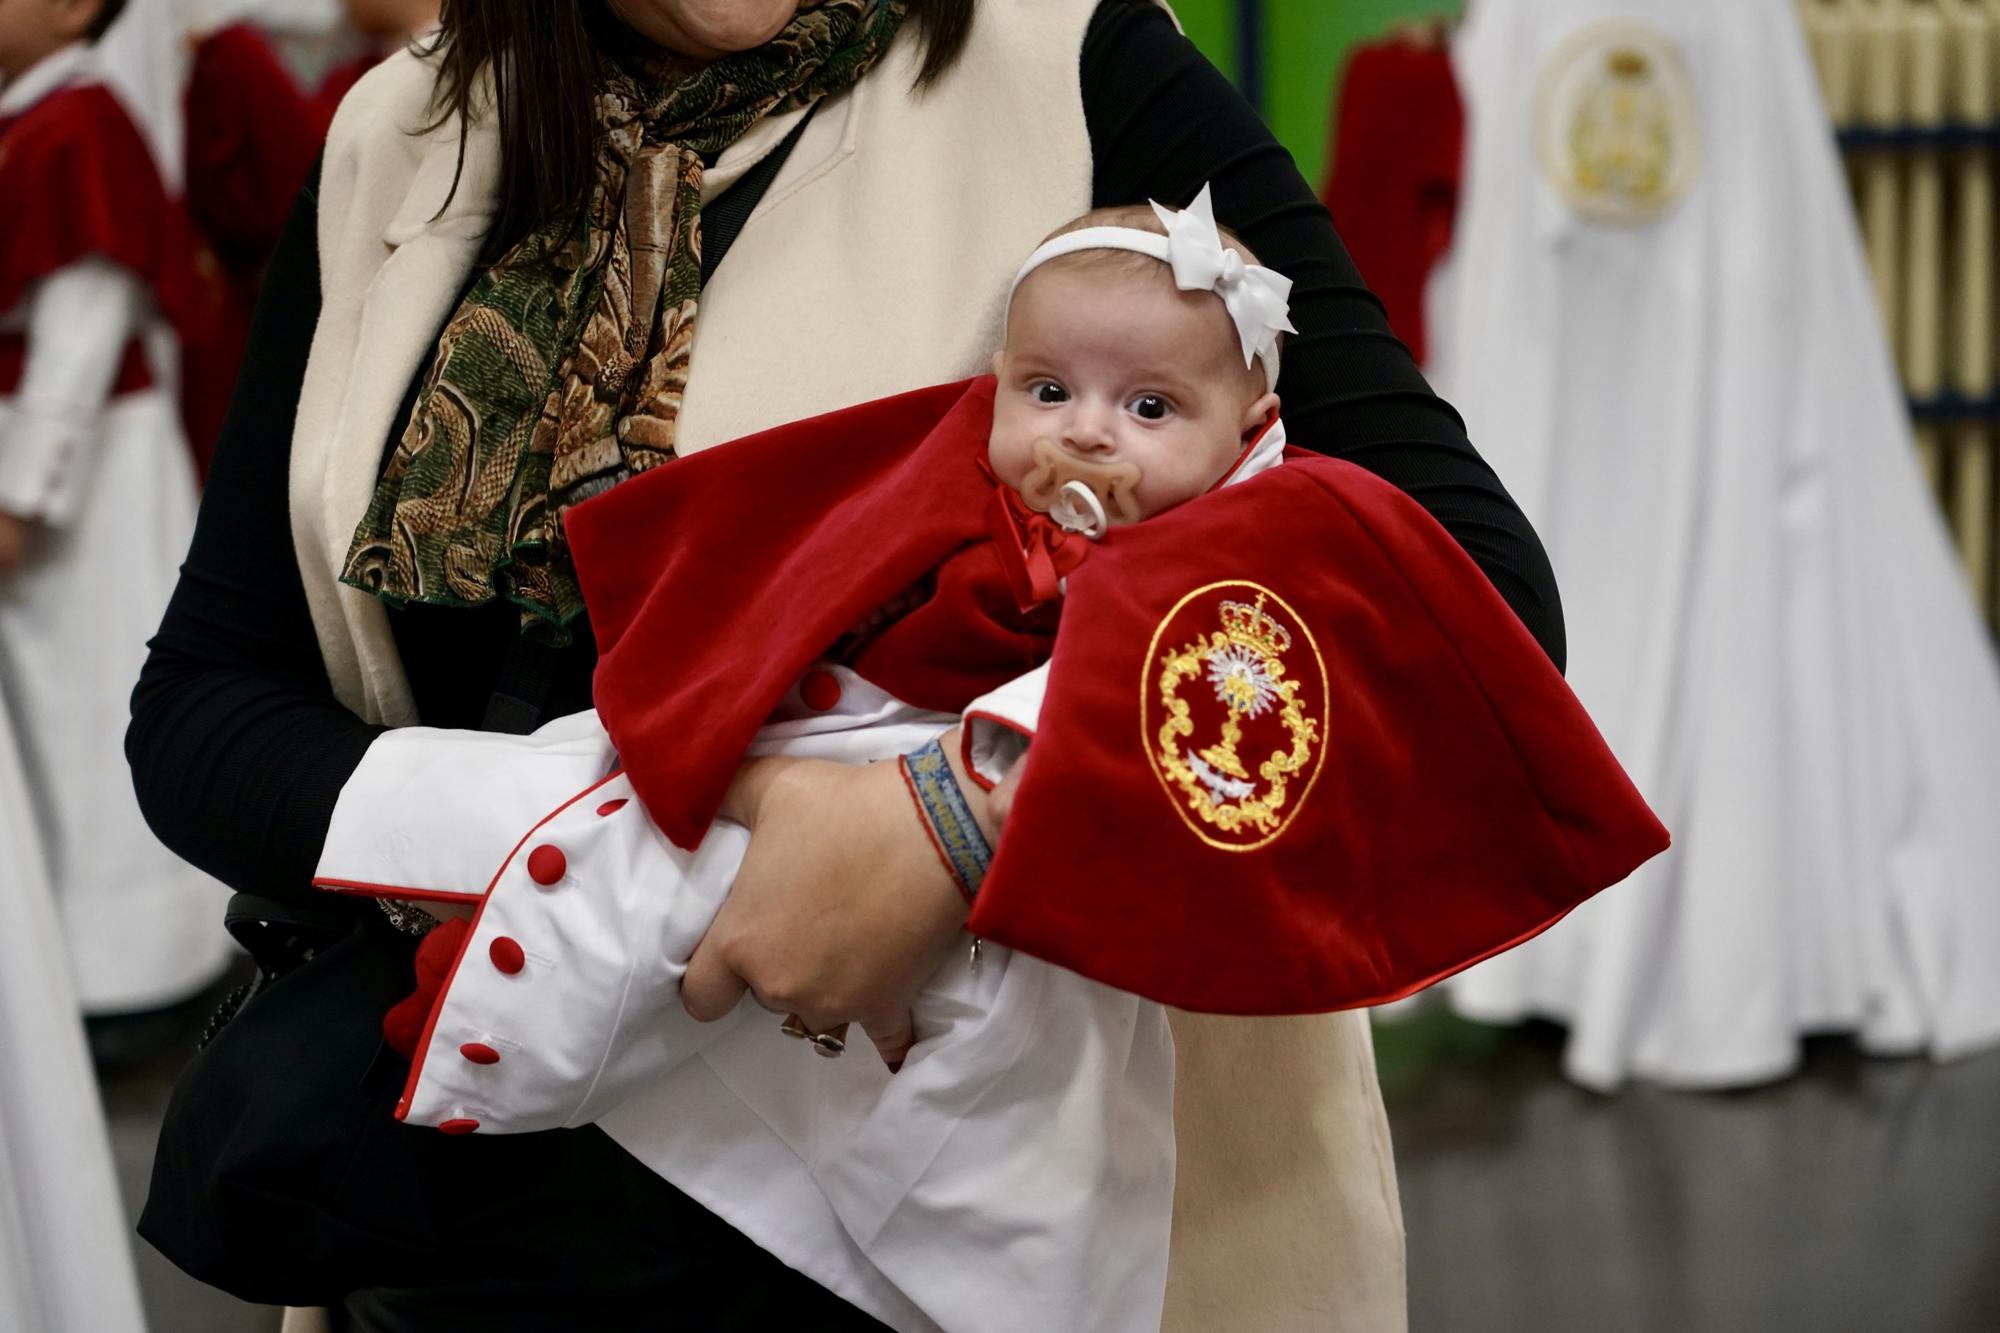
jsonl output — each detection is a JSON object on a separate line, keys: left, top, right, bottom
{"left": 1536, "top": 20, "right": 1702, "bottom": 226}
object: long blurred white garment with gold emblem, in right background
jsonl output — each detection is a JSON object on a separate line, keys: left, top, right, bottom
{"left": 1432, "top": 0, "right": 2000, "bottom": 1089}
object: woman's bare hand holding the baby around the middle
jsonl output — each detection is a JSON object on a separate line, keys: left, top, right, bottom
{"left": 680, "top": 759, "right": 978, "bottom": 1065}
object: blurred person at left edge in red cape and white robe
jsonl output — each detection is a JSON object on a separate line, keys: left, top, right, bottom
{"left": 0, "top": 2, "right": 230, "bottom": 1015}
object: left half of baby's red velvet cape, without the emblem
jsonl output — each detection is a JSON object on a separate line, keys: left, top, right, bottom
{"left": 564, "top": 378, "right": 1054, "bottom": 847}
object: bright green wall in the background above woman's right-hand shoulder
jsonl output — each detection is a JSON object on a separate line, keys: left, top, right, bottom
{"left": 1170, "top": 0, "right": 1464, "bottom": 186}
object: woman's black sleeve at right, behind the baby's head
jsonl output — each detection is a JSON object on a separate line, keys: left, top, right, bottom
{"left": 1082, "top": 0, "right": 1564, "bottom": 667}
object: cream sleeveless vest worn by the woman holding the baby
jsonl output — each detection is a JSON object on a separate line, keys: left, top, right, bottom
{"left": 290, "top": 0, "right": 1404, "bottom": 1333}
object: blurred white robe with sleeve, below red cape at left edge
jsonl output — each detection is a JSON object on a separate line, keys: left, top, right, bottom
{"left": 0, "top": 260, "right": 230, "bottom": 1013}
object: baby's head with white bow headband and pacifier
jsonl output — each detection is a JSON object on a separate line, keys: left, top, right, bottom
{"left": 892, "top": 188, "right": 1292, "bottom": 889}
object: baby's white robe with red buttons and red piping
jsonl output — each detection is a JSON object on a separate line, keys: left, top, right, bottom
{"left": 316, "top": 667, "right": 1174, "bottom": 1333}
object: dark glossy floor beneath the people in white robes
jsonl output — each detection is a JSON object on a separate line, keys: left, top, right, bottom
{"left": 100, "top": 980, "right": 2000, "bottom": 1333}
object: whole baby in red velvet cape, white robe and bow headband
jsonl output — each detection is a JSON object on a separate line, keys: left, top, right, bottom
{"left": 316, "top": 190, "right": 1664, "bottom": 1331}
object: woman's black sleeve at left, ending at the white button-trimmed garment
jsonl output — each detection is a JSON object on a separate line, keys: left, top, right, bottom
{"left": 126, "top": 164, "right": 390, "bottom": 907}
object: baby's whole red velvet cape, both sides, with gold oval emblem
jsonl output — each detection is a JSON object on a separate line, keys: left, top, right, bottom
{"left": 568, "top": 380, "right": 1666, "bottom": 1013}
